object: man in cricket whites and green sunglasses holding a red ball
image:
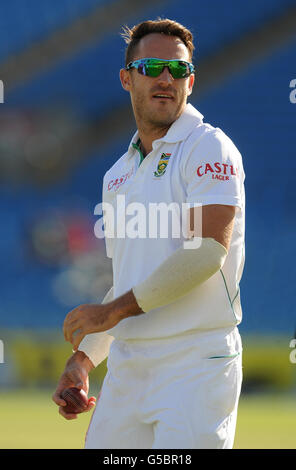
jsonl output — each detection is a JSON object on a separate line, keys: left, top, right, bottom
{"left": 53, "top": 20, "right": 244, "bottom": 449}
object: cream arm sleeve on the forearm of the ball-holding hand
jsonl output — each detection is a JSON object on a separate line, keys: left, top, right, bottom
{"left": 78, "top": 287, "right": 114, "bottom": 367}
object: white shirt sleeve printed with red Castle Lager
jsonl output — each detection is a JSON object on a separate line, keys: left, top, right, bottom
{"left": 184, "top": 129, "right": 244, "bottom": 207}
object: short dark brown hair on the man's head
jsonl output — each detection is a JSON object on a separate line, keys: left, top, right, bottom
{"left": 121, "top": 18, "right": 194, "bottom": 65}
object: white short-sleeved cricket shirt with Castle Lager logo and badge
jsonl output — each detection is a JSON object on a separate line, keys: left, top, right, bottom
{"left": 103, "top": 104, "right": 245, "bottom": 339}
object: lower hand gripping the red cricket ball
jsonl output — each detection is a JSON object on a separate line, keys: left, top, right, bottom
{"left": 52, "top": 351, "right": 96, "bottom": 420}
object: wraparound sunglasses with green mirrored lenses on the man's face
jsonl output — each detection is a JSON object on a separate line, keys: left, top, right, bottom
{"left": 126, "top": 58, "right": 195, "bottom": 78}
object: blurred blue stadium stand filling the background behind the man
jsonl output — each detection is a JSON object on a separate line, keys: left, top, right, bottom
{"left": 0, "top": 0, "right": 296, "bottom": 340}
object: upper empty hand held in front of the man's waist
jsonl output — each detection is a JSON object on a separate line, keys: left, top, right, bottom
{"left": 63, "top": 303, "right": 119, "bottom": 351}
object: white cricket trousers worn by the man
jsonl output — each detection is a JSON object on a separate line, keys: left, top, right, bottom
{"left": 85, "top": 328, "right": 242, "bottom": 449}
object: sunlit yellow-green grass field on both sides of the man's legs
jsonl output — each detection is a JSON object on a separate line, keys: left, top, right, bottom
{"left": 0, "top": 390, "right": 296, "bottom": 449}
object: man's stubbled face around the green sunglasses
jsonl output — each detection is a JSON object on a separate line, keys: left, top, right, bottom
{"left": 120, "top": 33, "right": 194, "bottom": 131}
